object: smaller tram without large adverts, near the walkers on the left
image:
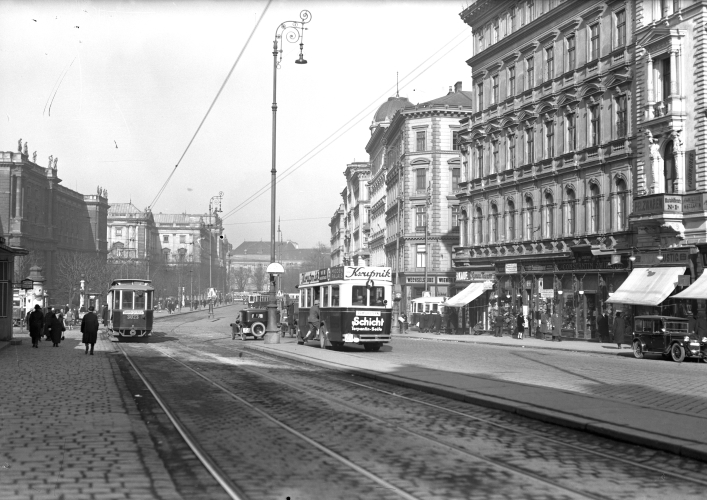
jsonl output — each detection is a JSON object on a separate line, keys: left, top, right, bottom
{"left": 107, "top": 279, "right": 155, "bottom": 340}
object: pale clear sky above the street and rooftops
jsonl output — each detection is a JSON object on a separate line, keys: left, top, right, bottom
{"left": 0, "top": 0, "right": 472, "bottom": 248}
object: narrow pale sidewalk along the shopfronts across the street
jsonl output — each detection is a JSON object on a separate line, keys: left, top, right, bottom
{"left": 393, "top": 329, "right": 631, "bottom": 356}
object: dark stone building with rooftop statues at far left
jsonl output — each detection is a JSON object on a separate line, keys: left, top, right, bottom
{"left": 0, "top": 143, "right": 108, "bottom": 292}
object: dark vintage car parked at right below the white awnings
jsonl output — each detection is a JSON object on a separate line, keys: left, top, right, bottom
{"left": 633, "top": 315, "right": 707, "bottom": 363}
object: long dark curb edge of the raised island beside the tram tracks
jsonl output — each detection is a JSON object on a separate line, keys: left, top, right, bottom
{"left": 244, "top": 339, "right": 707, "bottom": 462}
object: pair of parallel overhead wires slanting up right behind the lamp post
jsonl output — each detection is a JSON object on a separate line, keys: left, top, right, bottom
{"left": 221, "top": 30, "right": 471, "bottom": 220}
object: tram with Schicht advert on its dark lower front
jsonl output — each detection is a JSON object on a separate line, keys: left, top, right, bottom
{"left": 297, "top": 266, "right": 393, "bottom": 351}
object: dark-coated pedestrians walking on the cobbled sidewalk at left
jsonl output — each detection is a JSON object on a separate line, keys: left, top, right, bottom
{"left": 26, "top": 304, "right": 99, "bottom": 354}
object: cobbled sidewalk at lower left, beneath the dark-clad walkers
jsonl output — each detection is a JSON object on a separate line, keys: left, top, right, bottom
{"left": 0, "top": 328, "right": 182, "bottom": 500}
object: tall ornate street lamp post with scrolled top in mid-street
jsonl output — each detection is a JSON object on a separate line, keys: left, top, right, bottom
{"left": 263, "top": 10, "right": 312, "bottom": 344}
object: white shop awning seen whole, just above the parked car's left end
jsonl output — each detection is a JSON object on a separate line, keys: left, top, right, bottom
{"left": 606, "top": 266, "right": 685, "bottom": 306}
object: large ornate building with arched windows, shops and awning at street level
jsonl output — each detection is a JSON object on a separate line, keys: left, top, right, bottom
{"left": 453, "top": 0, "right": 636, "bottom": 338}
